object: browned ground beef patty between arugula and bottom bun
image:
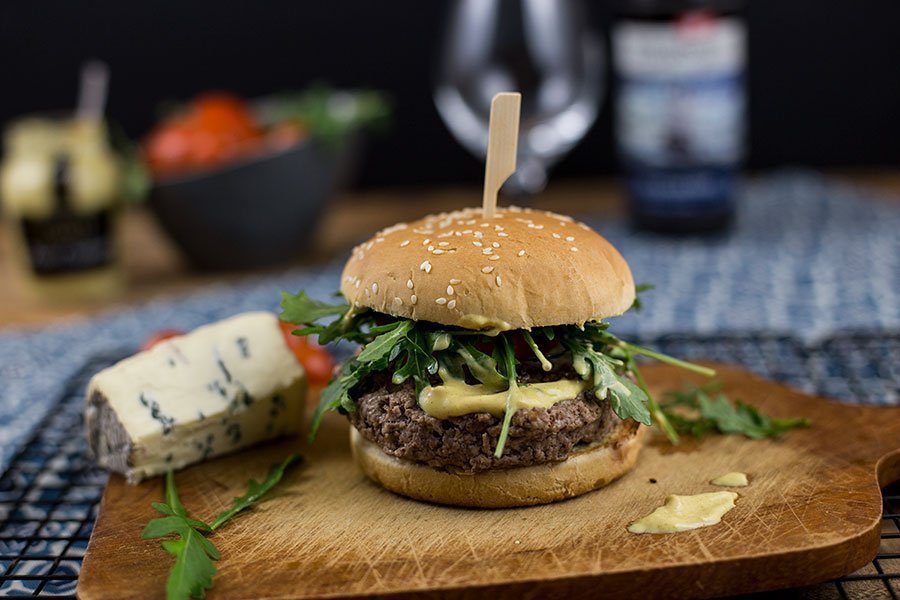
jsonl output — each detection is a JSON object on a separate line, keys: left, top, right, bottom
{"left": 348, "top": 372, "right": 637, "bottom": 473}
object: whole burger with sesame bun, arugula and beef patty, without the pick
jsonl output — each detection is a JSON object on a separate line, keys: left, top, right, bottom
{"left": 281, "top": 207, "right": 708, "bottom": 508}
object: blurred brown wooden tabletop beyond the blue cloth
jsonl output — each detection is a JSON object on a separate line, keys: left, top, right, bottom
{"left": 0, "top": 171, "right": 900, "bottom": 327}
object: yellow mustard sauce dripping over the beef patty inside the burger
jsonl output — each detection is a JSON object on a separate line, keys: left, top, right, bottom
{"left": 419, "top": 369, "right": 587, "bottom": 419}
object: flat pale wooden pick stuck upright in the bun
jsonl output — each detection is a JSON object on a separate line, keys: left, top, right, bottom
{"left": 482, "top": 92, "right": 522, "bottom": 219}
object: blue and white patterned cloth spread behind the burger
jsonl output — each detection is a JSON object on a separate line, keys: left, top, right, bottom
{"left": 0, "top": 173, "right": 900, "bottom": 471}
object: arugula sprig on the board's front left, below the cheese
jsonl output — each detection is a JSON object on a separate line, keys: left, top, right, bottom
{"left": 141, "top": 454, "right": 300, "bottom": 600}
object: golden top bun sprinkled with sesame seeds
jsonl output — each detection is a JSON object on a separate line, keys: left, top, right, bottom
{"left": 341, "top": 207, "right": 634, "bottom": 329}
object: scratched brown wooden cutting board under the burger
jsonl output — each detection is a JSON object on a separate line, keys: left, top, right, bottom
{"left": 78, "top": 365, "right": 900, "bottom": 600}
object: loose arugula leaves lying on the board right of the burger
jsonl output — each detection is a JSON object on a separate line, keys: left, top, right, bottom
{"left": 661, "top": 386, "right": 811, "bottom": 440}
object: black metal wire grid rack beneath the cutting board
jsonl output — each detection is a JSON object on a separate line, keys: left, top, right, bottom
{"left": 0, "top": 332, "right": 900, "bottom": 600}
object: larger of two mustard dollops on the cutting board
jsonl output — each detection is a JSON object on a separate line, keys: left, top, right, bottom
{"left": 628, "top": 492, "right": 738, "bottom": 533}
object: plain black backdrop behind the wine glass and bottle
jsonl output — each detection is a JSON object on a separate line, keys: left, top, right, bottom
{"left": 0, "top": 0, "right": 900, "bottom": 185}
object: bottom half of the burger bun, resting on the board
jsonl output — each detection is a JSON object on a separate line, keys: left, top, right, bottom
{"left": 350, "top": 421, "right": 647, "bottom": 508}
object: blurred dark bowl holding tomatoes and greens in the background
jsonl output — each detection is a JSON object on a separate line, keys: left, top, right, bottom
{"left": 149, "top": 138, "right": 356, "bottom": 270}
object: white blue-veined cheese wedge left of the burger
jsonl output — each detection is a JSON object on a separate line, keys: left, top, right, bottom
{"left": 85, "top": 312, "right": 306, "bottom": 483}
